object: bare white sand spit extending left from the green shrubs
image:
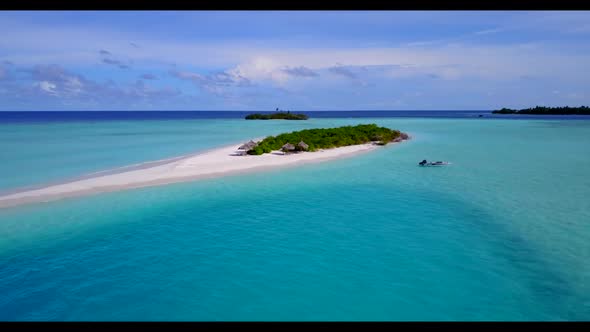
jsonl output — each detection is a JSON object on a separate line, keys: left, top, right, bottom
{"left": 0, "top": 144, "right": 396, "bottom": 207}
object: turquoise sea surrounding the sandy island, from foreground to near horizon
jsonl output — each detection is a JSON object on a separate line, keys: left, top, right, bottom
{"left": 0, "top": 118, "right": 590, "bottom": 320}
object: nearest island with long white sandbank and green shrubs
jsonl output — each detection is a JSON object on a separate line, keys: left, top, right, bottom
{"left": 0, "top": 124, "right": 409, "bottom": 208}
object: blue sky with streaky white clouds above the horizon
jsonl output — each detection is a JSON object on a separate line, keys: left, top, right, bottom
{"left": 0, "top": 11, "right": 590, "bottom": 111}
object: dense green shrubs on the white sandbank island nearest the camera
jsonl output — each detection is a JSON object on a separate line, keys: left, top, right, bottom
{"left": 248, "top": 124, "right": 408, "bottom": 155}
